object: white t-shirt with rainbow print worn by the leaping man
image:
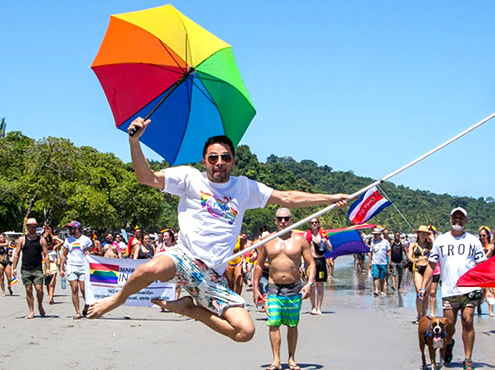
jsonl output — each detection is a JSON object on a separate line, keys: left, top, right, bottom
{"left": 163, "top": 166, "right": 273, "bottom": 275}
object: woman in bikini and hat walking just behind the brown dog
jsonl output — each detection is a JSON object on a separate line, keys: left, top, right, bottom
{"left": 407, "top": 225, "right": 433, "bottom": 323}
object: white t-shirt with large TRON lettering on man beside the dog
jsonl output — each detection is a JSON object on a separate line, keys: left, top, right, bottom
{"left": 428, "top": 231, "right": 486, "bottom": 298}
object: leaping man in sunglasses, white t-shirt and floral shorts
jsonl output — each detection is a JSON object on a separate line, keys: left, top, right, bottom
{"left": 88, "top": 118, "right": 349, "bottom": 342}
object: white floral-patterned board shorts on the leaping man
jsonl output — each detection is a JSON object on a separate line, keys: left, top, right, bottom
{"left": 160, "top": 246, "right": 246, "bottom": 316}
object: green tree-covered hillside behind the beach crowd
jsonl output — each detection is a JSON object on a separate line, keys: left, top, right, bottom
{"left": 0, "top": 132, "right": 495, "bottom": 236}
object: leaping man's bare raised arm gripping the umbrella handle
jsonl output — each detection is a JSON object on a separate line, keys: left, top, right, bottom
{"left": 127, "top": 117, "right": 165, "bottom": 190}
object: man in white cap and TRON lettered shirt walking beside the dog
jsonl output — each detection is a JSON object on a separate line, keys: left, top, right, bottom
{"left": 419, "top": 207, "right": 486, "bottom": 370}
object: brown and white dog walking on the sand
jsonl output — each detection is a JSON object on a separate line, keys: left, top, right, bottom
{"left": 418, "top": 316, "right": 447, "bottom": 370}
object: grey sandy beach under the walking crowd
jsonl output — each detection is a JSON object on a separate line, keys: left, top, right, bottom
{"left": 0, "top": 257, "right": 495, "bottom": 369}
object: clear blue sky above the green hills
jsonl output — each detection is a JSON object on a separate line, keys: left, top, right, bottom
{"left": 0, "top": 0, "right": 495, "bottom": 198}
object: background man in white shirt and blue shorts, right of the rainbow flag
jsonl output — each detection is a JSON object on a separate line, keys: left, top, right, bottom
{"left": 369, "top": 228, "right": 390, "bottom": 296}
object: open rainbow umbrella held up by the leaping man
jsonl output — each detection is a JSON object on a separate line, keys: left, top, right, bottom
{"left": 91, "top": 5, "right": 256, "bottom": 165}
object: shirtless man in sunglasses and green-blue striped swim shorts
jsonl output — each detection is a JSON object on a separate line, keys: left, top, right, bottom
{"left": 253, "top": 208, "right": 316, "bottom": 370}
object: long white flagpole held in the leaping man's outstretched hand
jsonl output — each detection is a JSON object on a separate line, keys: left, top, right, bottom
{"left": 218, "top": 113, "right": 495, "bottom": 268}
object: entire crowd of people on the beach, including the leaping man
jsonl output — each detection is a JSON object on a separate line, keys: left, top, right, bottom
{"left": 0, "top": 122, "right": 494, "bottom": 370}
